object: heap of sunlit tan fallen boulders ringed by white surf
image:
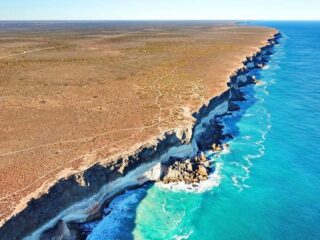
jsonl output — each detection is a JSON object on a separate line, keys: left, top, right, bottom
{"left": 161, "top": 153, "right": 211, "bottom": 184}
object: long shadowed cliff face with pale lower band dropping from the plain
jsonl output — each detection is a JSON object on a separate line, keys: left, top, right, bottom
{"left": 0, "top": 33, "right": 280, "bottom": 239}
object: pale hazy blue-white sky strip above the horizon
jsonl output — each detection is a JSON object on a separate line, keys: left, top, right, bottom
{"left": 0, "top": 0, "right": 320, "bottom": 20}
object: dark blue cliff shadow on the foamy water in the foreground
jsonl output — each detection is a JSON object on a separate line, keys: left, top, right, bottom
{"left": 80, "top": 183, "right": 153, "bottom": 240}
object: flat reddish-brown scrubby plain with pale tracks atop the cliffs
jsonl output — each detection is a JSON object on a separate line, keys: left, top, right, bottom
{"left": 0, "top": 22, "right": 275, "bottom": 222}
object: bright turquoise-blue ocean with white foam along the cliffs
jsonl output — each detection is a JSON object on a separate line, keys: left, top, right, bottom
{"left": 88, "top": 22, "right": 320, "bottom": 240}
